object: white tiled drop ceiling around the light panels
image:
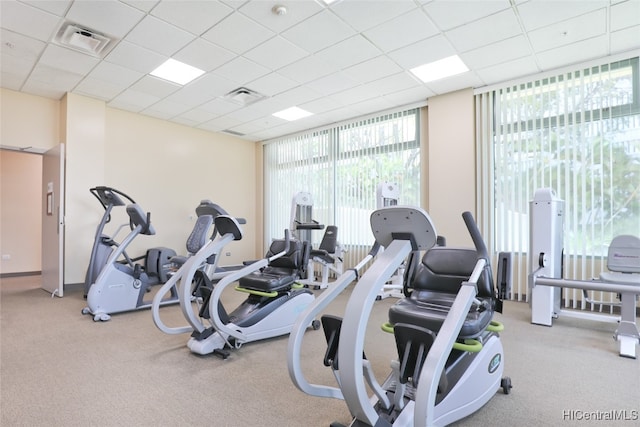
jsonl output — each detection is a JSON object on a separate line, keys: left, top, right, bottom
{"left": 0, "top": 0, "right": 640, "bottom": 141}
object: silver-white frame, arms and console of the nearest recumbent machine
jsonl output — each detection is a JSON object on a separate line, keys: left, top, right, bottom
{"left": 287, "top": 206, "right": 504, "bottom": 427}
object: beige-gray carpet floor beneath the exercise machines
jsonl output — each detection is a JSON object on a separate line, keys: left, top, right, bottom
{"left": 0, "top": 276, "right": 640, "bottom": 427}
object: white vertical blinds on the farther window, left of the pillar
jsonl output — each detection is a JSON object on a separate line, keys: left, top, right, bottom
{"left": 264, "top": 109, "right": 420, "bottom": 268}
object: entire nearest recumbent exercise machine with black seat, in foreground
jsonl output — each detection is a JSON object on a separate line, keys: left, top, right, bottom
{"left": 287, "top": 206, "right": 511, "bottom": 426}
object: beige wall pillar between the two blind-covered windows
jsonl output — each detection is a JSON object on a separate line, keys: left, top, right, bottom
{"left": 425, "top": 89, "right": 476, "bottom": 246}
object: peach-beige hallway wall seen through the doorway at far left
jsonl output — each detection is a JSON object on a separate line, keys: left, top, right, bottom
{"left": 0, "top": 150, "right": 43, "bottom": 274}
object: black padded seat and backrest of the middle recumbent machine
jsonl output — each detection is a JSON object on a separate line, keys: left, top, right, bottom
{"left": 238, "top": 239, "right": 309, "bottom": 292}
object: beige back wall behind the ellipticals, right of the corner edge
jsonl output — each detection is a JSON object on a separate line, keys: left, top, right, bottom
{"left": 102, "top": 109, "right": 262, "bottom": 280}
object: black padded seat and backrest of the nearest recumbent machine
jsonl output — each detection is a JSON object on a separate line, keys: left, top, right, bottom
{"left": 389, "top": 246, "right": 495, "bottom": 339}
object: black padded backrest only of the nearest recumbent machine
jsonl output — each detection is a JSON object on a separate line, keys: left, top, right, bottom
{"left": 407, "top": 246, "right": 495, "bottom": 298}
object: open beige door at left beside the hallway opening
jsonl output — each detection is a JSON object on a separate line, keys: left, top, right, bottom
{"left": 42, "top": 144, "right": 64, "bottom": 297}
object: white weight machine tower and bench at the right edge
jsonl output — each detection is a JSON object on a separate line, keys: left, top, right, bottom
{"left": 528, "top": 188, "right": 640, "bottom": 359}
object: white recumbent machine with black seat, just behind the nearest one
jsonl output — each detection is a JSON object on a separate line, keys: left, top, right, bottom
{"left": 152, "top": 215, "right": 319, "bottom": 359}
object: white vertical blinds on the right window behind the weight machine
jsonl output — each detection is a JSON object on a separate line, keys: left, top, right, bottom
{"left": 476, "top": 58, "right": 640, "bottom": 312}
